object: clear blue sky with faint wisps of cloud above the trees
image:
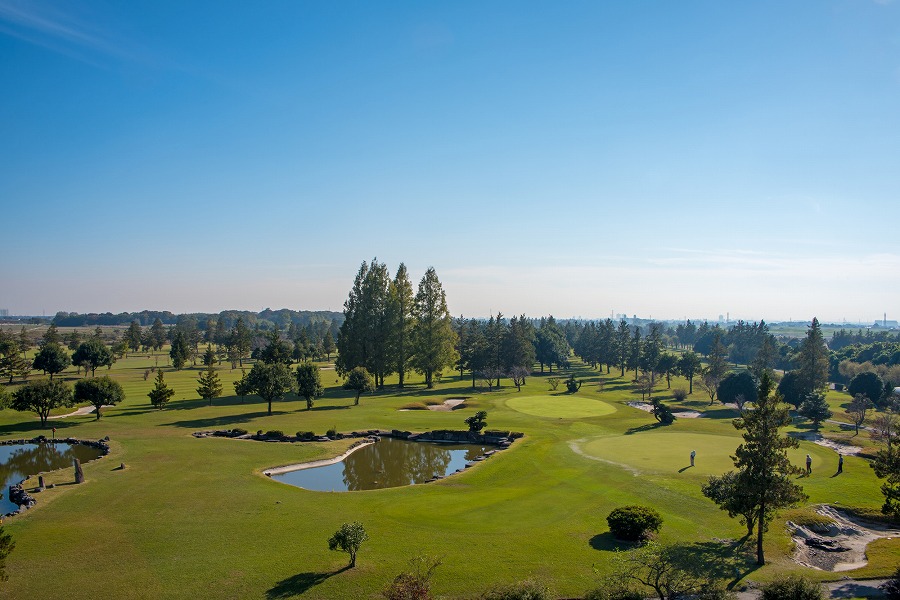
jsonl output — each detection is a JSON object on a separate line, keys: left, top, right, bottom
{"left": 0, "top": 0, "right": 900, "bottom": 321}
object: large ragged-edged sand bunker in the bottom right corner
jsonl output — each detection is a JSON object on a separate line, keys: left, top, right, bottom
{"left": 788, "top": 505, "right": 900, "bottom": 571}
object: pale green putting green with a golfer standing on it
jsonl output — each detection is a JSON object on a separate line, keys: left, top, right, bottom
{"left": 579, "top": 431, "right": 741, "bottom": 475}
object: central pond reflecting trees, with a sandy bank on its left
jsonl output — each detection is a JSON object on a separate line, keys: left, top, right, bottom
{"left": 272, "top": 437, "right": 485, "bottom": 492}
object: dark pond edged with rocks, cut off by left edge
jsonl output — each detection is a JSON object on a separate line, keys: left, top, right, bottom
{"left": 0, "top": 443, "right": 103, "bottom": 515}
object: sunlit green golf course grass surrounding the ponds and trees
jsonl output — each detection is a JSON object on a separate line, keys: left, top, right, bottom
{"left": 0, "top": 354, "right": 900, "bottom": 599}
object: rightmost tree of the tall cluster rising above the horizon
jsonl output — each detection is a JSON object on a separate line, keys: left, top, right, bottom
{"left": 412, "top": 267, "right": 456, "bottom": 388}
